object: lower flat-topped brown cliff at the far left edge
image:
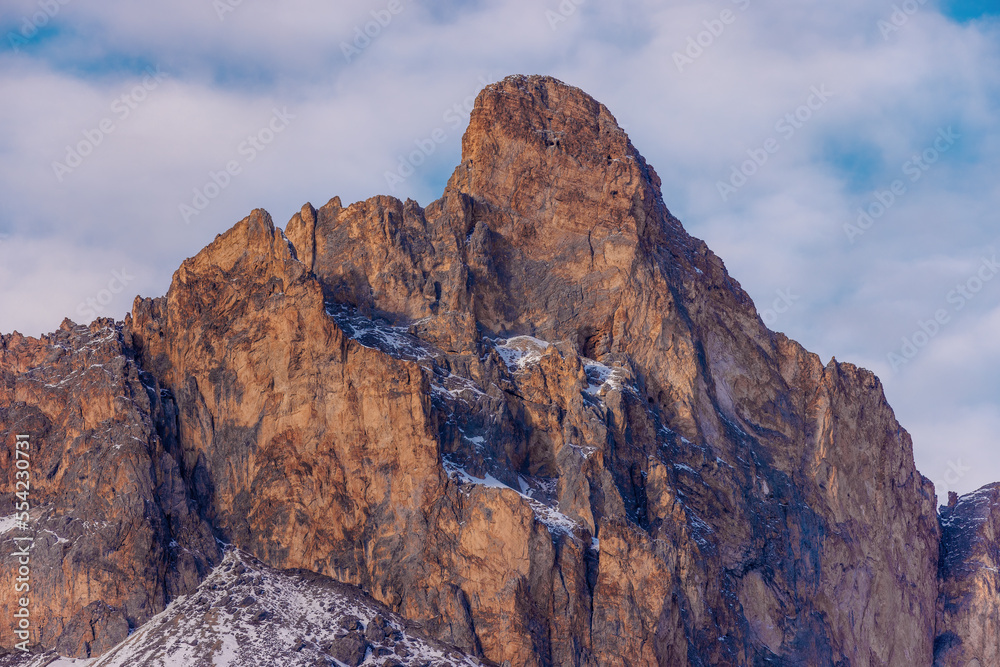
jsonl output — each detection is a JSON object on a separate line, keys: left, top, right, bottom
{"left": 0, "top": 320, "right": 219, "bottom": 657}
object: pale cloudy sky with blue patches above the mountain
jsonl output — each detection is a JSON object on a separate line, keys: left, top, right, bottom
{"left": 0, "top": 0, "right": 1000, "bottom": 499}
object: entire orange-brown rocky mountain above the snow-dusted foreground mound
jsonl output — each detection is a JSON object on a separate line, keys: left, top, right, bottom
{"left": 0, "top": 77, "right": 984, "bottom": 667}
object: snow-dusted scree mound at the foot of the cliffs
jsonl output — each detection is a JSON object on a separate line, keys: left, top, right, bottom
{"left": 0, "top": 549, "right": 483, "bottom": 667}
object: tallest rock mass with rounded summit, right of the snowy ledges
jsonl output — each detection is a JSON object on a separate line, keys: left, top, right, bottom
{"left": 272, "top": 77, "right": 937, "bottom": 664}
